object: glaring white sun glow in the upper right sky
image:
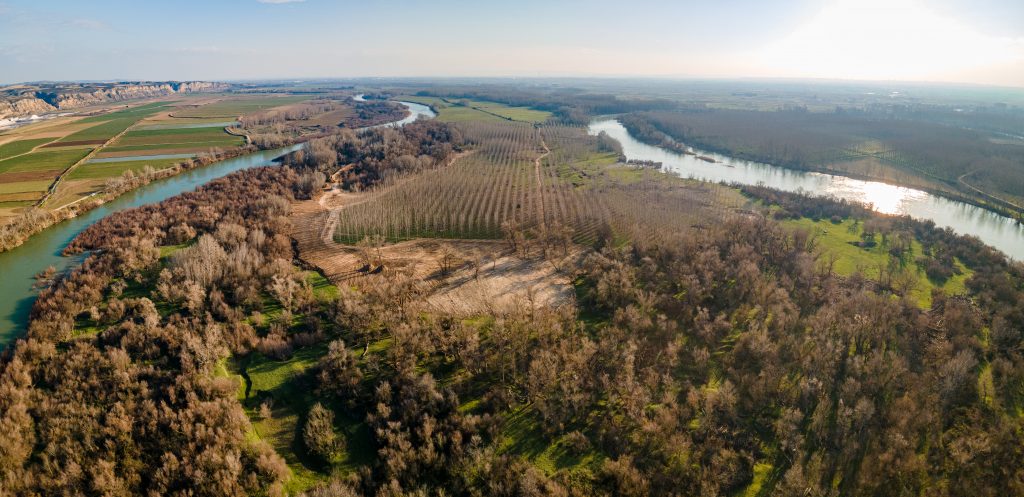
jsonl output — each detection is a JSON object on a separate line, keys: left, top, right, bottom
{"left": 756, "top": 0, "right": 1024, "bottom": 80}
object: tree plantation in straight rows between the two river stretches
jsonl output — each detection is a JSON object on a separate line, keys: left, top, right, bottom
{"left": 335, "top": 121, "right": 742, "bottom": 245}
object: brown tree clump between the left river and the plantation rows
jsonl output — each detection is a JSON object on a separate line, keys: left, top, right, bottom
{"left": 285, "top": 121, "right": 463, "bottom": 191}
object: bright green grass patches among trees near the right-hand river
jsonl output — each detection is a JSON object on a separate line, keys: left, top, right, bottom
{"left": 781, "top": 217, "right": 974, "bottom": 308}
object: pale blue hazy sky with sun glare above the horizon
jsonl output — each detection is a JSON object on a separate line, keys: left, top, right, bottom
{"left": 0, "top": 0, "right": 1024, "bottom": 86}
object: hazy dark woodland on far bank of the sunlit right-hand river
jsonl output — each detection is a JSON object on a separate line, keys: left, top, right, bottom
{"left": 621, "top": 108, "right": 1024, "bottom": 205}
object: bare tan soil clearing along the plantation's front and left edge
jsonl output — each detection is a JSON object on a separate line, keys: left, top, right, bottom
{"left": 290, "top": 184, "right": 580, "bottom": 316}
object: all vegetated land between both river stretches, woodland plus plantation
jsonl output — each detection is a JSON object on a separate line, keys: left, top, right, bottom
{"left": 0, "top": 100, "right": 1024, "bottom": 496}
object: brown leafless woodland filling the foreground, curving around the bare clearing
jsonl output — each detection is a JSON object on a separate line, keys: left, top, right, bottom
{"left": 0, "top": 117, "right": 1024, "bottom": 496}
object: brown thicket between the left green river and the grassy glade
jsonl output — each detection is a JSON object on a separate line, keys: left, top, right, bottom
{"left": 0, "top": 168, "right": 301, "bottom": 496}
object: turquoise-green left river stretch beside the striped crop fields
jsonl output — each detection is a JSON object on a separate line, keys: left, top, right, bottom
{"left": 0, "top": 101, "right": 436, "bottom": 348}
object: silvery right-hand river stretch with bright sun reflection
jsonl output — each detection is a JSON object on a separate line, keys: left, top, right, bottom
{"left": 589, "top": 118, "right": 1024, "bottom": 260}
